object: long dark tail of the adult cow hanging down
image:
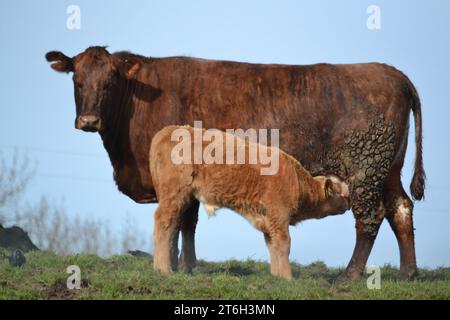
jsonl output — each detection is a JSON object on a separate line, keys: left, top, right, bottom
{"left": 408, "top": 83, "right": 426, "bottom": 200}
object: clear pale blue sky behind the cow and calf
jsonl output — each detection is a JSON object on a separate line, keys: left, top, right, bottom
{"left": 0, "top": 0, "right": 450, "bottom": 267}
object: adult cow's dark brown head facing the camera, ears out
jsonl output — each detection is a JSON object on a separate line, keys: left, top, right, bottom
{"left": 45, "top": 47, "right": 140, "bottom": 132}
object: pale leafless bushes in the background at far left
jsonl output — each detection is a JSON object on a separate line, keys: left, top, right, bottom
{"left": 0, "top": 153, "right": 145, "bottom": 256}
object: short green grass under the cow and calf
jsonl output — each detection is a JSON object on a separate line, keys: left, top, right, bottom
{"left": 0, "top": 251, "right": 450, "bottom": 299}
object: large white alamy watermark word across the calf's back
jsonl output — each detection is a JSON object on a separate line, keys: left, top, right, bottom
{"left": 171, "top": 121, "right": 280, "bottom": 175}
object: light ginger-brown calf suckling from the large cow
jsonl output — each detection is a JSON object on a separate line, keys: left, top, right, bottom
{"left": 149, "top": 126, "right": 350, "bottom": 279}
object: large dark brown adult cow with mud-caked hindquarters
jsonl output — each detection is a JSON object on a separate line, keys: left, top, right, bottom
{"left": 46, "top": 47, "right": 425, "bottom": 278}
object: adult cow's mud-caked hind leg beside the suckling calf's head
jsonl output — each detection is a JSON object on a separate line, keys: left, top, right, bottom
{"left": 341, "top": 115, "right": 395, "bottom": 279}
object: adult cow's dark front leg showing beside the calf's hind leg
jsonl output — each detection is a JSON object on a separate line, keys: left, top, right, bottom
{"left": 179, "top": 200, "right": 199, "bottom": 273}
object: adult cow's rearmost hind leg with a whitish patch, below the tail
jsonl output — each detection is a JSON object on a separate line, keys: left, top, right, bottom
{"left": 383, "top": 168, "right": 417, "bottom": 280}
